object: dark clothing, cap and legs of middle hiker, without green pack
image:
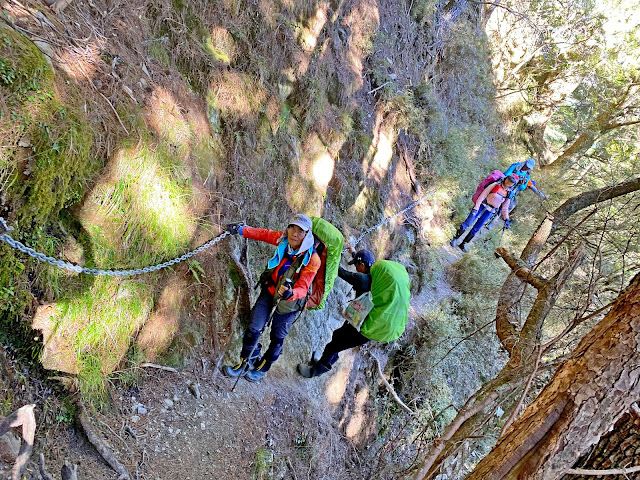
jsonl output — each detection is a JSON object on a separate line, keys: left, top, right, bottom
{"left": 298, "top": 246, "right": 375, "bottom": 378}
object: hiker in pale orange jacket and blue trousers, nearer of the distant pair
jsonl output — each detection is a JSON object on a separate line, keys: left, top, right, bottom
{"left": 451, "top": 170, "right": 520, "bottom": 252}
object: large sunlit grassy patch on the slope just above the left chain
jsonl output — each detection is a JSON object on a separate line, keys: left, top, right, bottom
{"left": 80, "top": 145, "right": 196, "bottom": 268}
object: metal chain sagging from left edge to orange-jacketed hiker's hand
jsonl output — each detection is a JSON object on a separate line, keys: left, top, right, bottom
{"left": 0, "top": 217, "right": 229, "bottom": 277}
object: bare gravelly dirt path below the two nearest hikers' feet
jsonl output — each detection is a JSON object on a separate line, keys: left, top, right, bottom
{"left": 54, "top": 352, "right": 364, "bottom": 480}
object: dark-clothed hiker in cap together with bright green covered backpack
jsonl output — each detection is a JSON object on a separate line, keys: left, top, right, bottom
{"left": 298, "top": 253, "right": 411, "bottom": 378}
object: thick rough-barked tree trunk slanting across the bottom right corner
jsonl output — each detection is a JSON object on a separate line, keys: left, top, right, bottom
{"left": 467, "top": 275, "right": 640, "bottom": 480}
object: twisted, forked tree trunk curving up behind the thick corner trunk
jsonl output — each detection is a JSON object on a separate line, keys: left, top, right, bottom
{"left": 413, "top": 178, "right": 640, "bottom": 480}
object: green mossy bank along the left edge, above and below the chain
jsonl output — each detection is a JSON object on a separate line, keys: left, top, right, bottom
{"left": 0, "top": 26, "right": 99, "bottom": 360}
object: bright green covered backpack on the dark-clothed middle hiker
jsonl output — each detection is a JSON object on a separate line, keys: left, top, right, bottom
{"left": 360, "top": 260, "right": 411, "bottom": 342}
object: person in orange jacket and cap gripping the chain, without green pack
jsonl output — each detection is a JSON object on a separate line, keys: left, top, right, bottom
{"left": 222, "top": 214, "right": 320, "bottom": 382}
